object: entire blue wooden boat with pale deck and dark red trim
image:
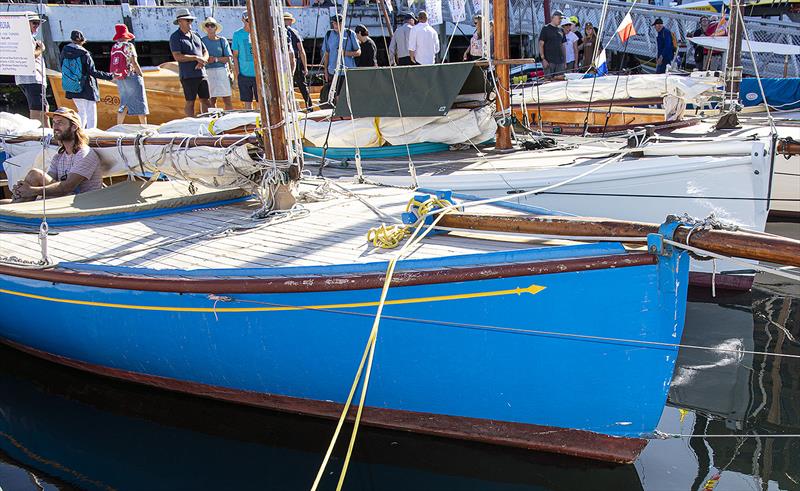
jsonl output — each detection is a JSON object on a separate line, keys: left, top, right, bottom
{"left": 0, "top": 181, "right": 689, "bottom": 462}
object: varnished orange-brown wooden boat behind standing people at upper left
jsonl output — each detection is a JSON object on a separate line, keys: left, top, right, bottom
{"left": 47, "top": 62, "right": 321, "bottom": 129}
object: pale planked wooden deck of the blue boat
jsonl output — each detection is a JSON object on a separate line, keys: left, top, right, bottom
{"left": 0, "top": 184, "right": 560, "bottom": 270}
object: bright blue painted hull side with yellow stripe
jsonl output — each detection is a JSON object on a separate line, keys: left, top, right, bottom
{"left": 0, "top": 245, "right": 689, "bottom": 464}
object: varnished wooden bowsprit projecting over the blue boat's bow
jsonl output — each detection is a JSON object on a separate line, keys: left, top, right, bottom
{"left": 439, "top": 213, "right": 800, "bottom": 267}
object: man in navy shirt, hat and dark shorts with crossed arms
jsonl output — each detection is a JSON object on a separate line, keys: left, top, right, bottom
{"left": 169, "top": 9, "right": 209, "bottom": 118}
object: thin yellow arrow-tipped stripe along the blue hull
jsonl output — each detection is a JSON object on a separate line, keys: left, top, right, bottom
{"left": 0, "top": 285, "right": 545, "bottom": 313}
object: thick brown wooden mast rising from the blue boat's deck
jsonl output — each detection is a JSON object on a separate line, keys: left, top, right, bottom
{"left": 247, "top": 0, "right": 300, "bottom": 180}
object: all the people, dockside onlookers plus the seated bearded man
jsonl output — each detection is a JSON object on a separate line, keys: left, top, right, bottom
{"left": 13, "top": 8, "right": 720, "bottom": 201}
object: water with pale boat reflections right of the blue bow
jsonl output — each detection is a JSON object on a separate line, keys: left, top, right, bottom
{"left": 637, "top": 286, "right": 800, "bottom": 490}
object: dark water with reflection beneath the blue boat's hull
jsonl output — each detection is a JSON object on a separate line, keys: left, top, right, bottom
{"left": 0, "top": 346, "right": 641, "bottom": 490}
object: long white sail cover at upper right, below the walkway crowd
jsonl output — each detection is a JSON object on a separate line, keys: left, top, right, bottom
{"left": 511, "top": 73, "right": 722, "bottom": 104}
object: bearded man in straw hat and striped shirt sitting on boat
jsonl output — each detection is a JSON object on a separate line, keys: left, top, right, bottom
{"left": 12, "top": 107, "right": 103, "bottom": 203}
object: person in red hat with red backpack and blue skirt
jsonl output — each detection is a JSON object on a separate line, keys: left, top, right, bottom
{"left": 108, "top": 24, "right": 150, "bottom": 124}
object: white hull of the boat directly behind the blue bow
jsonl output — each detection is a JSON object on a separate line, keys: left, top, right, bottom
{"left": 369, "top": 143, "right": 769, "bottom": 282}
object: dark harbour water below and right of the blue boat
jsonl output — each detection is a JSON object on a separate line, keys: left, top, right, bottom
{"left": 0, "top": 224, "right": 800, "bottom": 491}
